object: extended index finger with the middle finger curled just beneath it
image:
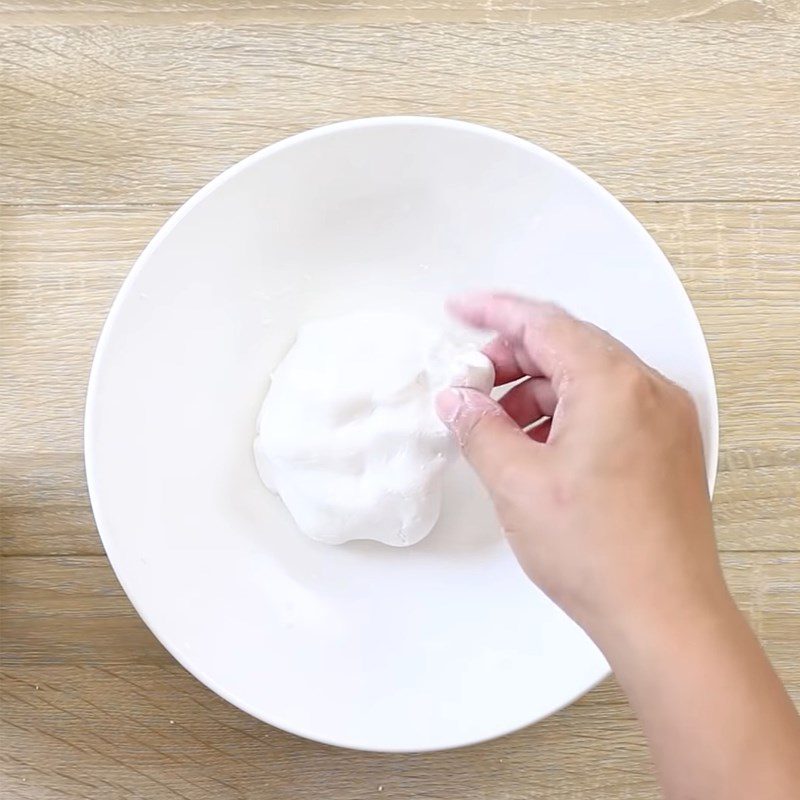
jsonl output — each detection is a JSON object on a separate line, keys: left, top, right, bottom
{"left": 448, "top": 293, "right": 615, "bottom": 394}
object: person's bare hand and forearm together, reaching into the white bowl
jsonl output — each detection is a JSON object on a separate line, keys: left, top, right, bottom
{"left": 437, "top": 294, "right": 800, "bottom": 800}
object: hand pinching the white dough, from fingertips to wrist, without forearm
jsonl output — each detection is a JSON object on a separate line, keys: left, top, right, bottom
{"left": 437, "top": 294, "right": 727, "bottom": 646}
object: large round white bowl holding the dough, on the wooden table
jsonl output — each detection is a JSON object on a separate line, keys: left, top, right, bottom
{"left": 85, "top": 117, "right": 717, "bottom": 751}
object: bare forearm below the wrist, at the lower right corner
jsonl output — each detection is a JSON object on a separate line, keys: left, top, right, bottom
{"left": 601, "top": 589, "right": 800, "bottom": 800}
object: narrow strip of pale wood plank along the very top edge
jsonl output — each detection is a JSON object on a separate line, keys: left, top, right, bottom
{"left": 0, "top": 0, "right": 800, "bottom": 26}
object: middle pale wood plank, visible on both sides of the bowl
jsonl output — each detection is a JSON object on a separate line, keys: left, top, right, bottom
{"left": 0, "top": 203, "right": 800, "bottom": 554}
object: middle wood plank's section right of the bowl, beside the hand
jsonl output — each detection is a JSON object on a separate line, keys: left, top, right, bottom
{"left": 631, "top": 204, "right": 800, "bottom": 549}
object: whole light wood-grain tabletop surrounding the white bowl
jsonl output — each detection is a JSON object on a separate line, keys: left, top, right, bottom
{"left": 0, "top": 0, "right": 800, "bottom": 800}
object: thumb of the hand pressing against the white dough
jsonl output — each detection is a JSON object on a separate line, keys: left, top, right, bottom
{"left": 436, "top": 388, "right": 541, "bottom": 491}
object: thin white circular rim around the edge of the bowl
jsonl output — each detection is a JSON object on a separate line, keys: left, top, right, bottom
{"left": 83, "top": 115, "right": 719, "bottom": 753}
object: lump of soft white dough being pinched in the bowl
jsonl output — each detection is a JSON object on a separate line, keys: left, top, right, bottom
{"left": 255, "top": 313, "right": 494, "bottom": 546}
